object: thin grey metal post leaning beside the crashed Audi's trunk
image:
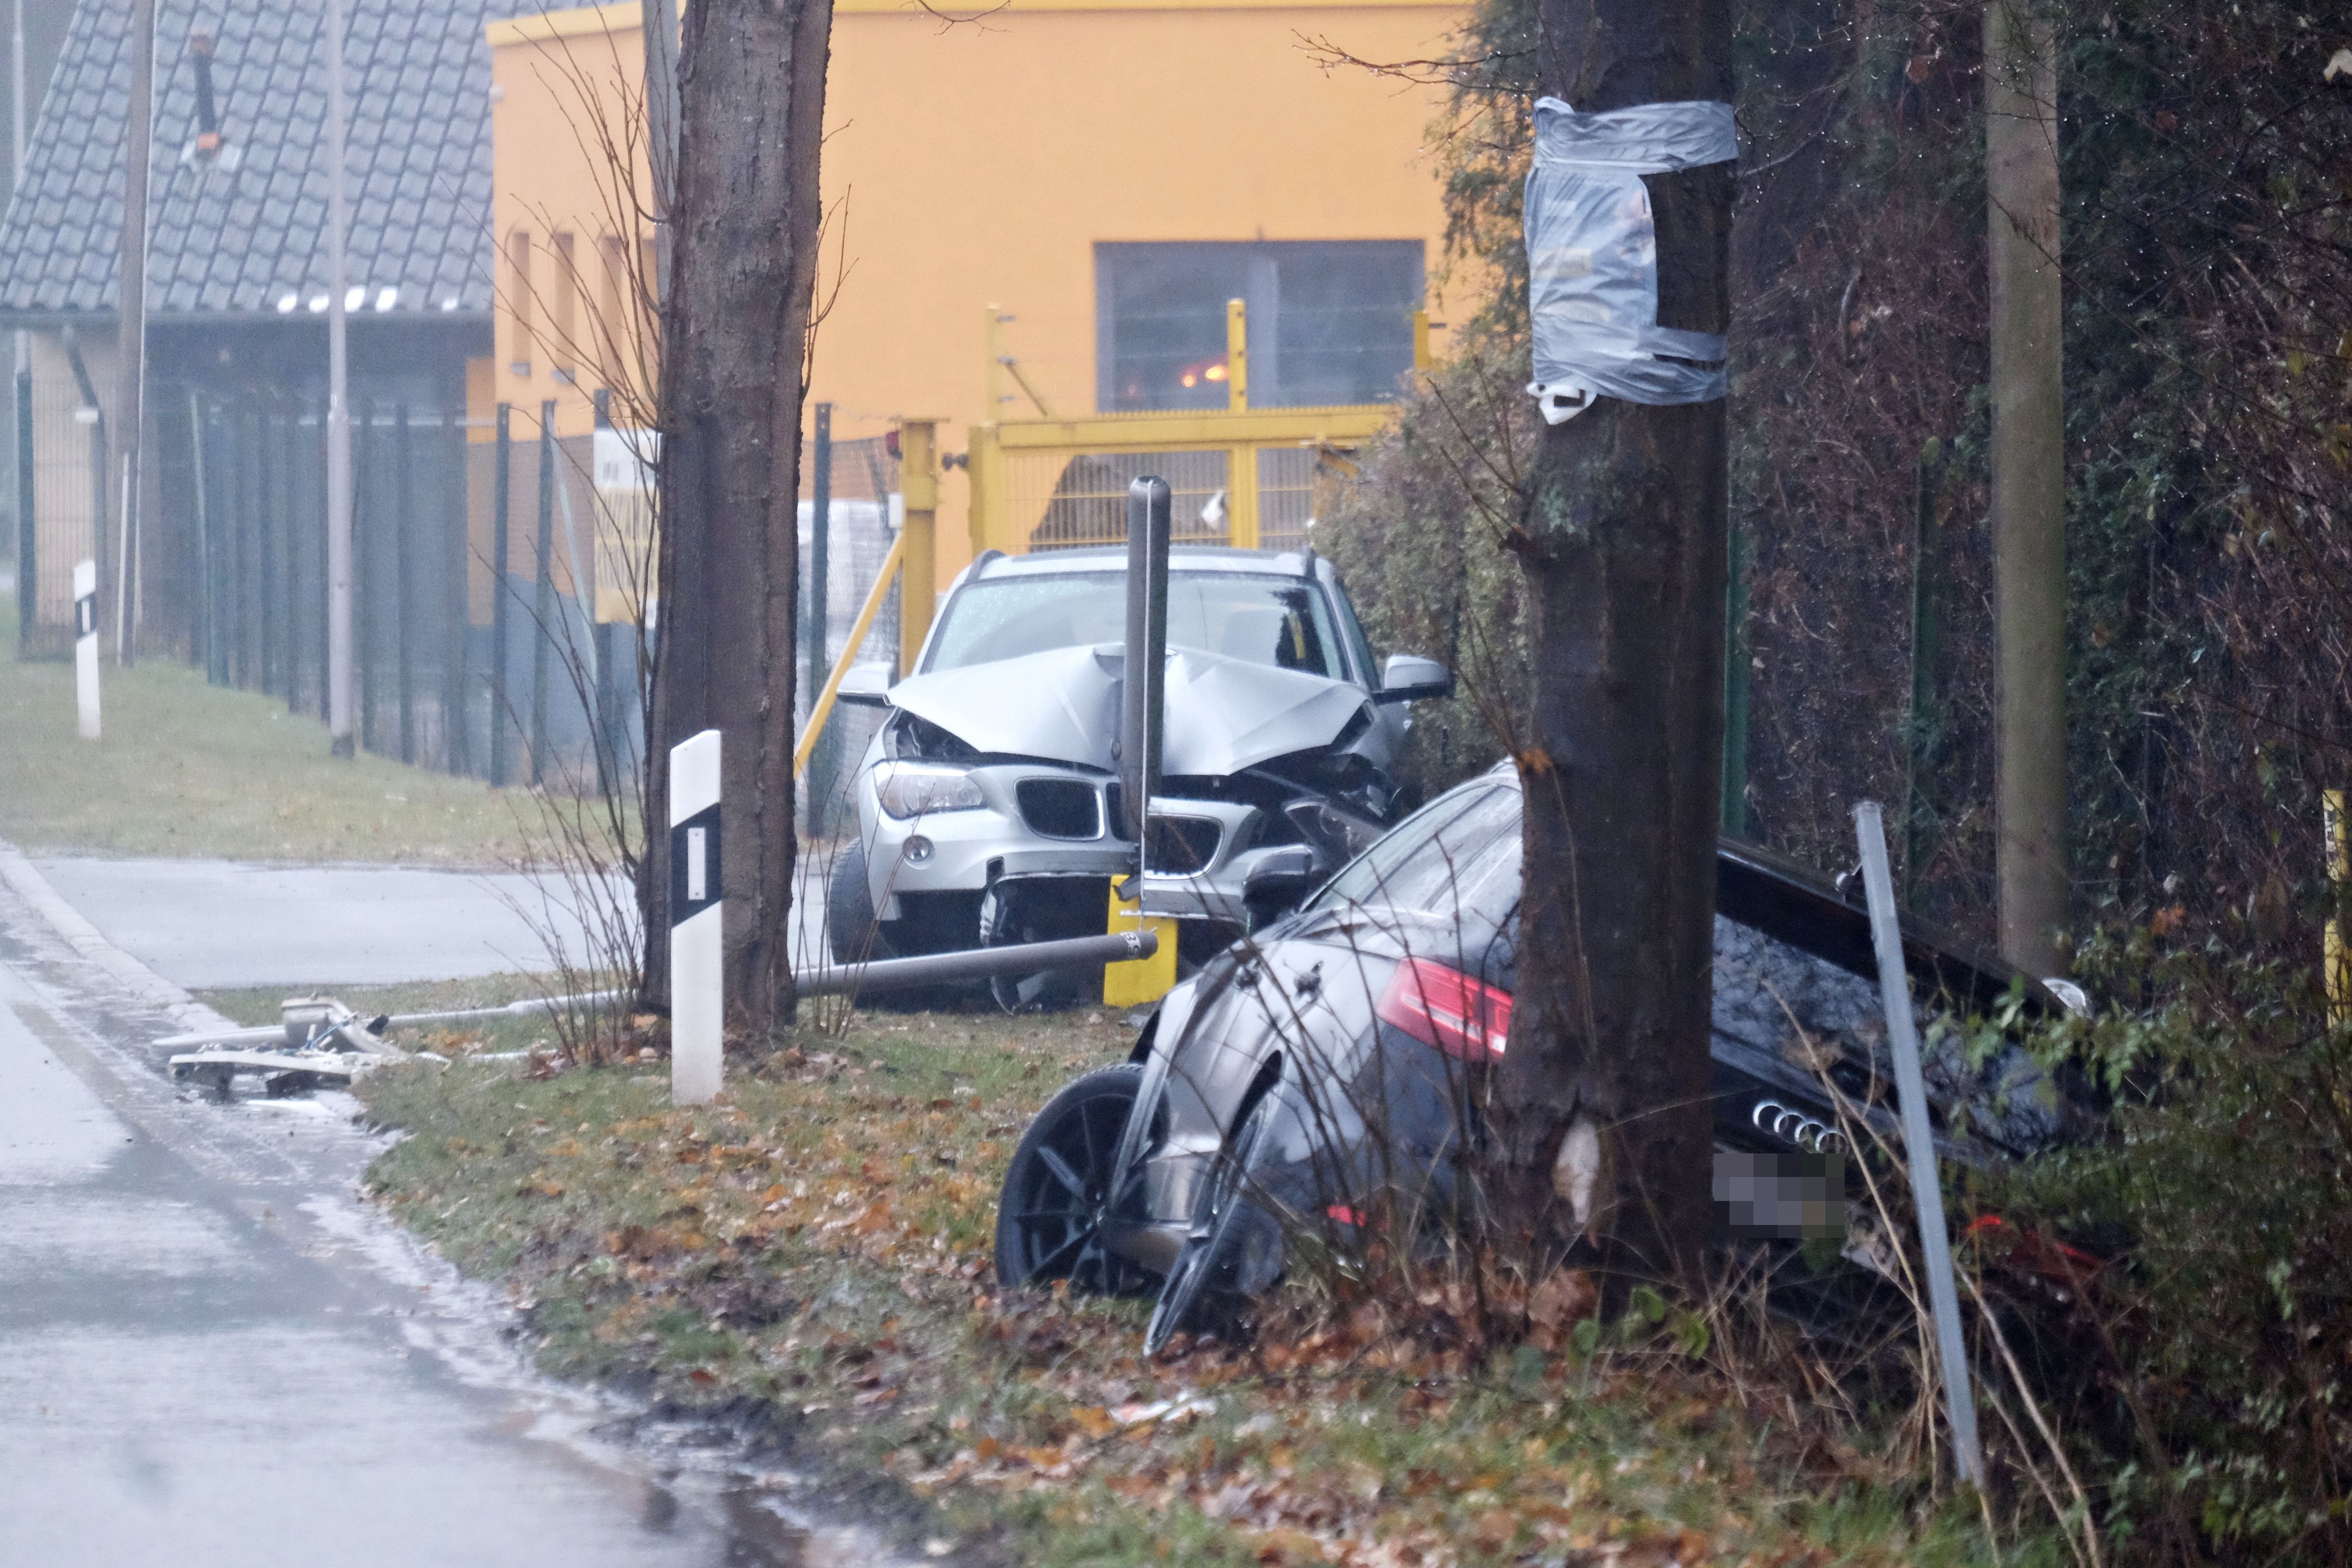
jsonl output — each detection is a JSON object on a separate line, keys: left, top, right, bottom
{"left": 1853, "top": 799, "right": 1985, "bottom": 1486}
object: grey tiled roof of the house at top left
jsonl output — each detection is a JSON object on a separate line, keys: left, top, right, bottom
{"left": 0, "top": 0, "right": 543, "bottom": 318}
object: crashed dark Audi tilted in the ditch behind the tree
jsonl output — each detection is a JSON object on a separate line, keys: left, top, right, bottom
{"left": 997, "top": 764, "right": 2091, "bottom": 1349}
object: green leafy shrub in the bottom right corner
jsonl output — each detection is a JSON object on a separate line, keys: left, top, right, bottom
{"left": 2021, "top": 917, "right": 2352, "bottom": 1563}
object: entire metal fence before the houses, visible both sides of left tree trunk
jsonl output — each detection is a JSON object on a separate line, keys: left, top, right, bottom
{"left": 19, "top": 376, "right": 903, "bottom": 832}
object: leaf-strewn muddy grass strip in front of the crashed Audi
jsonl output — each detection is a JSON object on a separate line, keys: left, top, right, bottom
{"left": 360, "top": 1011, "right": 2032, "bottom": 1568}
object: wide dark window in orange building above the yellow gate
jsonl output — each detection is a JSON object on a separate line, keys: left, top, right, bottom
{"left": 1094, "top": 240, "right": 1423, "bottom": 411}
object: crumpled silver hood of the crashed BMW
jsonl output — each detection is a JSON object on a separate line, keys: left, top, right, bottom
{"left": 889, "top": 642, "right": 1364, "bottom": 778}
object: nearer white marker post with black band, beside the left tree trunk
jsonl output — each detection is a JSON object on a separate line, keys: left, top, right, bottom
{"left": 670, "top": 729, "right": 727, "bottom": 1105}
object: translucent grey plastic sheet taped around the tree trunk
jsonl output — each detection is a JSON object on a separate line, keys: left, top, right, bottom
{"left": 1527, "top": 99, "right": 1738, "bottom": 426}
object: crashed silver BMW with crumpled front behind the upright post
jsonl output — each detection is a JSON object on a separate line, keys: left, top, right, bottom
{"left": 828, "top": 548, "right": 1451, "bottom": 1006}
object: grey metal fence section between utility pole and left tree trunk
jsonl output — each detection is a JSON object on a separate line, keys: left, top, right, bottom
{"left": 141, "top": 390, "right": 651, "bottom": 787}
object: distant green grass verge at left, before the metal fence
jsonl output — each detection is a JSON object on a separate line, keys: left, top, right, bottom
{"left": 0, "top": 597, "right": 539, "bottom": 868}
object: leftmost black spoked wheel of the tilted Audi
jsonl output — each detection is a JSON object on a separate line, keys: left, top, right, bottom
{"left": 997, "top": 1063, "right": 1160, "bottom": 1295}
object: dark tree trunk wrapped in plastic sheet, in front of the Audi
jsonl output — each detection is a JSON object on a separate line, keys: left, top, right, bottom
{"left": 1498, "top": 0, "right": 1731, "bottom": 1279}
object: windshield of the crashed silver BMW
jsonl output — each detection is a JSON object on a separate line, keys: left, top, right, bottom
{"left": 924, "top": 571, "right": 1348, "bottom": 679}
